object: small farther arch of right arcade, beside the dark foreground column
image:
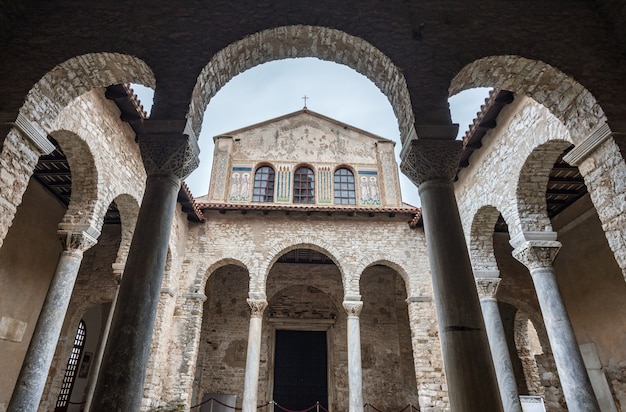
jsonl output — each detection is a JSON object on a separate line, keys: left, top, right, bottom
{"left": 467, "top": 205, "right": 500, "bottom": 277}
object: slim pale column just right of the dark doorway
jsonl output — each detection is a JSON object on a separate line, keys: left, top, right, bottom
{"left": 343, "top": 295, "right": 363, "bottom": 412}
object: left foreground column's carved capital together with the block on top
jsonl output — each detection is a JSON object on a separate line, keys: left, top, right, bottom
{"left": 138, "top": 120, "right": 200, "bottom": 179}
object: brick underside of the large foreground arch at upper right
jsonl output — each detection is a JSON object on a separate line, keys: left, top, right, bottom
{"left": 449, "top": 55, "right": 607, "bottom": 144}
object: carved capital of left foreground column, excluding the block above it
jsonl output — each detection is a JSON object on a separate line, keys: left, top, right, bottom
{"left": 139, "top": 132, "right": 200, "bottom": 179}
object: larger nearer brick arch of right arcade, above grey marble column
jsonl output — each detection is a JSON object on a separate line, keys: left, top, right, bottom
{"left": 511, "top": 140, "right": 570, "bottom": 233}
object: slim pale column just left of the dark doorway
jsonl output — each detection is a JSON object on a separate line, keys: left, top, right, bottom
{"left": 242, "top": 293, "right": 267, "bottom": 412}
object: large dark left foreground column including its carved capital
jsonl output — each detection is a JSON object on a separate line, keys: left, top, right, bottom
{"left": 92, "top": 120, "right": 199, "bottom": 411}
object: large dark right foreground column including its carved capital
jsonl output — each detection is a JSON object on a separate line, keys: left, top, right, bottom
{"left": 401, "top": 134, "right": 502, "bottom": 412}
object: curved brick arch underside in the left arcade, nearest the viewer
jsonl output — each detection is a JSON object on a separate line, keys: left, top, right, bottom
{"left": 50, "top": 130, "right": 100, "bottom": 230}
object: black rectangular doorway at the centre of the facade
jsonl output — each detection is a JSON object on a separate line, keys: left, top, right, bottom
{"left": 274, "top": 330, "right": 328, "bottom": 410}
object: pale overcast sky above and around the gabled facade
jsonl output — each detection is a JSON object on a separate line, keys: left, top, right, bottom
{"left": 133, "top": 58, "right": 488, "bottom": 206}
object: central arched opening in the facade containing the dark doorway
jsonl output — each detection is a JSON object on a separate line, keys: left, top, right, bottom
{"left": 259, "top": 248, "right": 348, "bottom": 411}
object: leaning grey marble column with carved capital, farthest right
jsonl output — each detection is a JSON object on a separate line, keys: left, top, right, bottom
{"left": 513, "top": 240, "right": 600, "bottom": 412}
